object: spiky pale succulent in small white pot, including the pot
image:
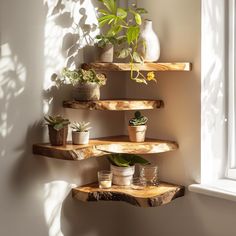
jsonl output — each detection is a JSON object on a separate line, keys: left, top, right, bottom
{"left": 71, "top": 121, "right": 91, "bottom": 144}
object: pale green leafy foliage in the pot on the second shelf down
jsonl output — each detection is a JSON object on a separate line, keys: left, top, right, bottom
{"left": 54, "top": 68, "right": 106, "bottom": 86}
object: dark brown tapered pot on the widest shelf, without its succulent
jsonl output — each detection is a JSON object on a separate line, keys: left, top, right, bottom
{"left": 48, "top": 125, "right": 68, "bottom": 146}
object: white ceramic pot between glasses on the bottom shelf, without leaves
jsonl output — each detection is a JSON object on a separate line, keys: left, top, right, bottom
{"left": 110, "top": 165, "right": 135, "bottom": 186}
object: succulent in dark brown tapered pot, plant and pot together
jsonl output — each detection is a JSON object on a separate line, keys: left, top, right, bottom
{"left": 44, "top": 115, "right": 70, "bottom": 146}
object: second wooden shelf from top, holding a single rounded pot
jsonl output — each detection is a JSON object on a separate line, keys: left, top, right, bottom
{"left": 63, "top": 99, "right": 164, "bottom": 111}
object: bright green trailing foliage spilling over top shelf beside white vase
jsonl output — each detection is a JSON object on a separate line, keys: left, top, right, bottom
{"left": 98, "top": 0, "right": 156, "bottom": 84}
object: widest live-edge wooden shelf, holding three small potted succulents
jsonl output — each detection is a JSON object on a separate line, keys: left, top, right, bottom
{"left": 33, "top": 136, "right": 178, "bottom": 161}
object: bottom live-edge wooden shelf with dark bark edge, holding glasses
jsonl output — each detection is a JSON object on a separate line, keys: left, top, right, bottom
{"left": 72, "top": 182, "right": 185, "bottom": 207}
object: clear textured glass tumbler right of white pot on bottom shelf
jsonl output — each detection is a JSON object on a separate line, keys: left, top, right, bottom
{"left": 140, "top": 165, "right": 159, "bottom": 186}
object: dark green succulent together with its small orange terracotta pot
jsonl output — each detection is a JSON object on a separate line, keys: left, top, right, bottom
{"left": 128, "top": 111, "right": 148, "bottom": 142}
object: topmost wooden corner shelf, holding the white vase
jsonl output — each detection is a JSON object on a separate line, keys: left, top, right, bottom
{"left": 82, "top": 62, "right": 192, "bottom": 71}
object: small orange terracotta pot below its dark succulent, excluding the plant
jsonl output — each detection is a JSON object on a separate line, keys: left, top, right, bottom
{"left": 128, "top": 125, "right": 147, "bottom": 142}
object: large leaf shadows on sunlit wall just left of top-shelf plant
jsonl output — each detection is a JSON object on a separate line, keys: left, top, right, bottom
{"left": 51, "top": 0, "right": 97, "bottom": 67}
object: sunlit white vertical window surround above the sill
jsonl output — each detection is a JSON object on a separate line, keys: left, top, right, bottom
{"left": 201, "top": 0, "right": 226, "bottom": 183}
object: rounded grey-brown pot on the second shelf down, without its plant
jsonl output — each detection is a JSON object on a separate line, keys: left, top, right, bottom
{"left": 72, "top": 82, "right": 100, "bottom": 101}
